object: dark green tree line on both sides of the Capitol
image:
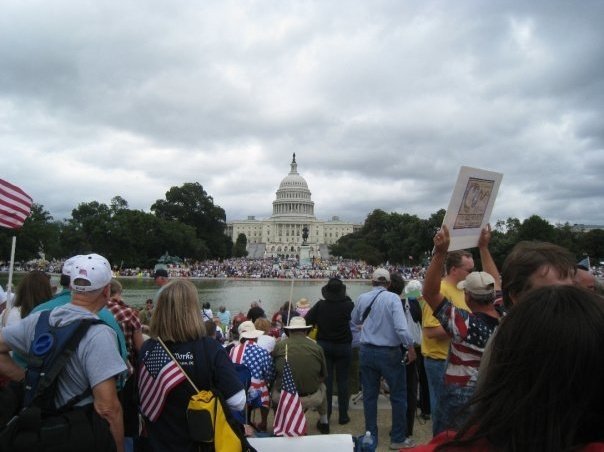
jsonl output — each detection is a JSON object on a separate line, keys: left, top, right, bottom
{"left": 0, "top": 182, "right": 604, "bottom": 268}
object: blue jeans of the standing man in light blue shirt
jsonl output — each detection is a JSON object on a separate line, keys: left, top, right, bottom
{"left": 360, "top": 344, "right": 407, "bottom": 443}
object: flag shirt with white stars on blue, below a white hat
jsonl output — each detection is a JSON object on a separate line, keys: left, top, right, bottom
{"left": 229, "top": 340, "right": 275, "bottom": 408}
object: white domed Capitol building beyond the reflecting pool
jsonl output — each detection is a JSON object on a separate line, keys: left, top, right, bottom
{"left": 226, "top": 154, "right": 362, "bottom": 258}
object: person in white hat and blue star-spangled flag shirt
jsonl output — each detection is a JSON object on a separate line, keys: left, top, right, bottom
{"left": 229, "top": 320, "right": 275, "bottom": 432}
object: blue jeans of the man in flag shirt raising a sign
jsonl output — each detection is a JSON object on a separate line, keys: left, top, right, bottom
{"left": 432, "top": 384, "right": 475, "bottom": 435}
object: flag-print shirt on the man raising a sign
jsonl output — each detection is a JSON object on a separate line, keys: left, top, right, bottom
{"left": 434, "top": 299, "right": 499, "bottom": 386}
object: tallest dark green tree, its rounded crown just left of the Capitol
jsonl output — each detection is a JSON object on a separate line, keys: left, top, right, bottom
{"left": 151, "top": 182, "right": 227, "bottom": 257}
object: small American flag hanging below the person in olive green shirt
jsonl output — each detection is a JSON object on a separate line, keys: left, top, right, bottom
{"left": 273, "top": 361, "right": 306, "bottom": 436}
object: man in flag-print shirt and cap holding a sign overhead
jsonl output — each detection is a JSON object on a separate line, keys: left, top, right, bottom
{"left": 423, "top": 225, "right": 503, "bottom": 435}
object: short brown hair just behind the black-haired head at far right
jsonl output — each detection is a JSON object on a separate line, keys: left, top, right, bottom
{"left": 501, "top": 241, "right": 575, "bottom": 307}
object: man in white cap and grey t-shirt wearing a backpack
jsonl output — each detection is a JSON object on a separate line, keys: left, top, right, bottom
{"left": 0, "top": 254, "right": 126, "bottom": 451}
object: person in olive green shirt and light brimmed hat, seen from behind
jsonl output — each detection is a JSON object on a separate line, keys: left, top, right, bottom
{"left": 272, "top": 317, "right": 329, "bottom": 434}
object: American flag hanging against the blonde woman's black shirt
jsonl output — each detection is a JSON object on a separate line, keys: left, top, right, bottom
{"left": 138, "top": 342, "right": 186, "bottom": 422}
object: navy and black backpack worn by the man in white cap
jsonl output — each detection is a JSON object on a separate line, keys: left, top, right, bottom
{"left": 0, "top": 311, "right": 115, "bottom": 452}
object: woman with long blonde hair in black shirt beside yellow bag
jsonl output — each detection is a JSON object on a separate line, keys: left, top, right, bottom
{"left": 139, "top": 279, "right": 245, "bottom": 452}
